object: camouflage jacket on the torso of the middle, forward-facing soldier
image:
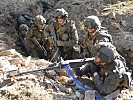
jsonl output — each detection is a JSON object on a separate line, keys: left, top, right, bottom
{"left": 46, "top": 20, "right": 79, "bottom": 47}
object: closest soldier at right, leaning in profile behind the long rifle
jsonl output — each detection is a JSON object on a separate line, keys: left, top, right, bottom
{"left": 77, "top": 42, "right": 131, "bottom": 94}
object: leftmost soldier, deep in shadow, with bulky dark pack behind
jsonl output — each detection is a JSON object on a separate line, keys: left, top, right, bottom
{"left": 9, "top": 12, "right": 33, "bottom": 56}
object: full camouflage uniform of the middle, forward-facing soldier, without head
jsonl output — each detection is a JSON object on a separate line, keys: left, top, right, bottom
{"left": 47, "top": 9, "right": 78, "bottom": 59}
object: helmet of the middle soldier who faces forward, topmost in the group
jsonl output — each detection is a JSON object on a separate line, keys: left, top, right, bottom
{"left": 54, "top": 8, "right": 68, "bottom": 18}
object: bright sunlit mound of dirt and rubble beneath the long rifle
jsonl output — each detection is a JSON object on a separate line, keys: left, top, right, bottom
{"left": 0, "top": 49, "right": 133, "bottom": 100}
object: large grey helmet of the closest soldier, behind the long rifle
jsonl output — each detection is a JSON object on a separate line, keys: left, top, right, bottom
{"left": 91, "top": 42, "right": 118, "bottom": 63}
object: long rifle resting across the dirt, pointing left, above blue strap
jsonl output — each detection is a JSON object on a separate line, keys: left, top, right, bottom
{"left": 7, "top": 58, "right": 94, "bottom": 77}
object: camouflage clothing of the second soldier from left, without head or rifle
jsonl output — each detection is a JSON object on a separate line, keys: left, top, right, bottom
{"left": 25, "top": 26, "right": 49, "bottom": 59}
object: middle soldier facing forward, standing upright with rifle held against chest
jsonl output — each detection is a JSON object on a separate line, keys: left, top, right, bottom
{"left": 46, "top": 8, "right": 78, "bottom": 59}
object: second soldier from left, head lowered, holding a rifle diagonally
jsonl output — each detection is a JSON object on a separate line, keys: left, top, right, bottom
{"left": 25, "top": 15, "right": 47, "bottom": 59}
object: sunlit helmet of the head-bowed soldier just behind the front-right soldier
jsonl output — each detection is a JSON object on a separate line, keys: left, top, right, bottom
{"left": 83, "top": 15, "right": 101, "bottom": 30}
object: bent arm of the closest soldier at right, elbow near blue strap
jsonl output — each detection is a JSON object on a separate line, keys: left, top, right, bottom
{"left": 93, "top": 72, "right": 120, "bottom": 94}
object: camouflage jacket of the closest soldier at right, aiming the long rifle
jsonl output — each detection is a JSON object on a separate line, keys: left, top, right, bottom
{"left": 93, "top": 57, "right": 129, "bottom": 94}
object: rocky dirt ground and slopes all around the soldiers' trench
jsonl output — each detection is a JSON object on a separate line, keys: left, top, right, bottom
{"left": 0, "top": 0, "right": 133, "bottom": 100}
